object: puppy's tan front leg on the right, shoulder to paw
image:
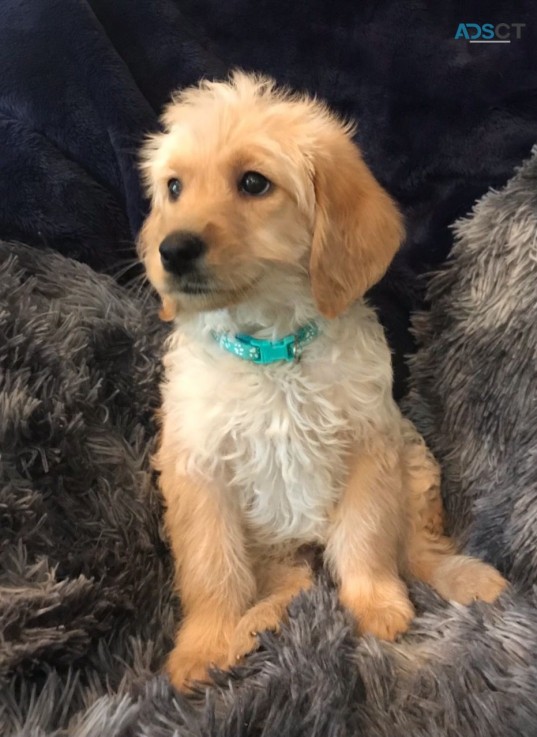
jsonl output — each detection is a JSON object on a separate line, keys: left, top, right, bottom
{"left": 326, "top": 443, "right": 414, "bottom": 640}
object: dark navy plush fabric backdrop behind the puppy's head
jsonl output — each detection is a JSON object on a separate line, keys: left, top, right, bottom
{"left": 0, "top": 0, "right": 537, "bottom": 393}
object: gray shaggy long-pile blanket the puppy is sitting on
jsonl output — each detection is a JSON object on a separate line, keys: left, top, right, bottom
{"left": 0, "top": 154, "right": 537, "bottom": 737}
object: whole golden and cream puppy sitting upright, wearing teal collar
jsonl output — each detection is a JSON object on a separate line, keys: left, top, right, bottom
{"left": 139, "top": 72, "right": 506, "bottom": 688}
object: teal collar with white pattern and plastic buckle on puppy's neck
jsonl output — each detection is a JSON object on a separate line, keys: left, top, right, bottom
{"left": 211, "top": 322, "right": 319, "bottom": 366}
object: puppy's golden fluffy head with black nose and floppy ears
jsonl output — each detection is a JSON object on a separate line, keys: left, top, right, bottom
{"left": 139, "top": 72, "right": 403, "bottom": 318}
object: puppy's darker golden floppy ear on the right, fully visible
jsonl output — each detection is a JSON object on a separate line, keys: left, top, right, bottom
{"left": 310, "top": 123, "right": 404, "bottom": 318}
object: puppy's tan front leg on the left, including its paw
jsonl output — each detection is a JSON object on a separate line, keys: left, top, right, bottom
{"left": 158, "top": 453, "right": 256, "bottom": 688}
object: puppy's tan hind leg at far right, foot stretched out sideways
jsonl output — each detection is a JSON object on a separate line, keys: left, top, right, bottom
{"left": 404, "top": 422, "right": 507, "bottom": 604}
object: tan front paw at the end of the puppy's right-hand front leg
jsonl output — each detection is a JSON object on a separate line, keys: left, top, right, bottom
{"left": 340, "top": 579, "right": 415, "bottom": 640}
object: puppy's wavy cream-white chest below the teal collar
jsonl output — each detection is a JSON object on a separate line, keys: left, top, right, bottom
{"left": 166, "top": 348, "right": 359, "bottom": 543}
